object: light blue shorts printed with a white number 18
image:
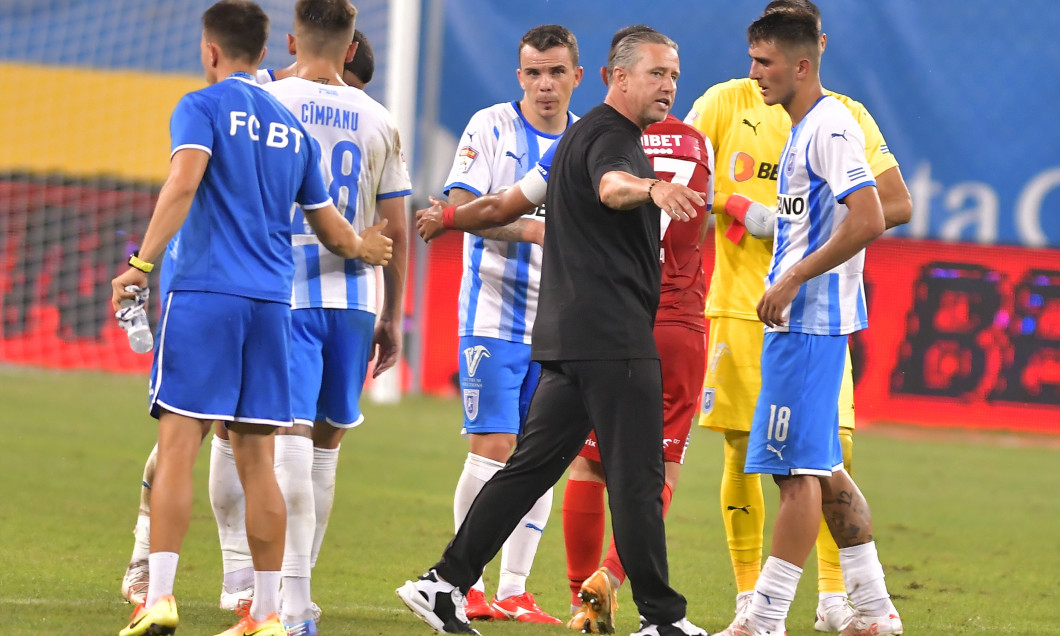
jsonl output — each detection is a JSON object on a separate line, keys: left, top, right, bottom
{"left": 744, "top": 332, "right": 847, "bottom": 476}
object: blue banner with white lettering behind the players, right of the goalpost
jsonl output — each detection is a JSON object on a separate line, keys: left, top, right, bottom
{"left": 440, "top": 0, "right": 1060, "bottom": 247}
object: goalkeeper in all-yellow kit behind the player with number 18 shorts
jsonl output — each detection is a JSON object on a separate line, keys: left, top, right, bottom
{"left": 685, "top": 0, "right": 913, "bottom": 632}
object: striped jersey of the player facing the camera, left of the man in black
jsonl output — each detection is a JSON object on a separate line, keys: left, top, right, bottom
{"left": 445, "top": 102, "right": 577, "bottom": 345}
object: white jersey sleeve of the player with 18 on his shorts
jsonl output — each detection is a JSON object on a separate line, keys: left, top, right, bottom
{"left": 810, "top": 108, "right": 876, "bottom": 202}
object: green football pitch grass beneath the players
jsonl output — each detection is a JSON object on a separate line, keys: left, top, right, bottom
{"left": 0, "top": 368, "right": 1060, "bottom": 636}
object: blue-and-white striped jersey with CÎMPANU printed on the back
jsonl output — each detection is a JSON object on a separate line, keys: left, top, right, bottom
{"left": 258, "top": 72, "right": 412, "bottom": 314}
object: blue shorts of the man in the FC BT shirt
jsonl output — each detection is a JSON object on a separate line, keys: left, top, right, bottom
{"left": 151, "top": 292, "right": 292, "bottom": 426}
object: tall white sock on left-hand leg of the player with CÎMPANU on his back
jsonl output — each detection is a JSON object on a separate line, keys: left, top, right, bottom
{"left": 275, "top": 435, "right": 317, "bottom": 620}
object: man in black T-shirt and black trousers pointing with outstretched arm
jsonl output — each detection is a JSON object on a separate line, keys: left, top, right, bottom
{"left": 398, "top": 27, "right": 706, "bottom": 636}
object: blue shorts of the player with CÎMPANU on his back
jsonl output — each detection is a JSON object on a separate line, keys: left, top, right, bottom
{"left": 290, "top": 307, "right": 375, "bottom": 428}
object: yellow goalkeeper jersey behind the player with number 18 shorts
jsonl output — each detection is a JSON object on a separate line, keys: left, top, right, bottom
{"left": 685, "top": 77, "right": 898, "bottom": 320}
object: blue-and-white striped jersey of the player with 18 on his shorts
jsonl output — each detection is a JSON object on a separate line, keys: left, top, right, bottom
{"left": 765, "top": 95, "right": 876, "bottom": 336}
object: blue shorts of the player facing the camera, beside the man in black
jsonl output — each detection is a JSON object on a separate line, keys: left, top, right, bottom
{"left": 460, "top": 336, "right": 541, "bottom": 435}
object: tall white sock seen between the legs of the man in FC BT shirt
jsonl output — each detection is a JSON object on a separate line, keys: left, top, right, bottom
{"left": 210, "top": 436, "right": 254, "bottom": 580}
